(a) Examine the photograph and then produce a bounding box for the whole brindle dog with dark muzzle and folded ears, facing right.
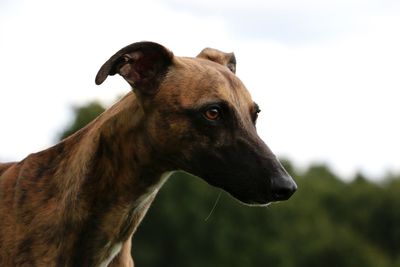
[0,42,296,266]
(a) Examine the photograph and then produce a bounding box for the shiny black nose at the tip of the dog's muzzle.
[271,174,297,201]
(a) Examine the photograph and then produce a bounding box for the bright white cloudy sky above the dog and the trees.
[0,0,400,179]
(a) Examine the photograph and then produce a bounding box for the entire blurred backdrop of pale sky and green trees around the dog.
[0,0,400,267]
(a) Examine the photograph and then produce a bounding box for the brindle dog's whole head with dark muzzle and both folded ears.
[96,42,297,205]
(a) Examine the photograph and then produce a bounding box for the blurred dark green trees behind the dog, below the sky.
[59,103,400,267]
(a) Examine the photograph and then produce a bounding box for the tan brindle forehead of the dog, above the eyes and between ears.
[160,57,253,108]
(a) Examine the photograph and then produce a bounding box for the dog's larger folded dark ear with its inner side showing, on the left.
[96,42,174,94]
